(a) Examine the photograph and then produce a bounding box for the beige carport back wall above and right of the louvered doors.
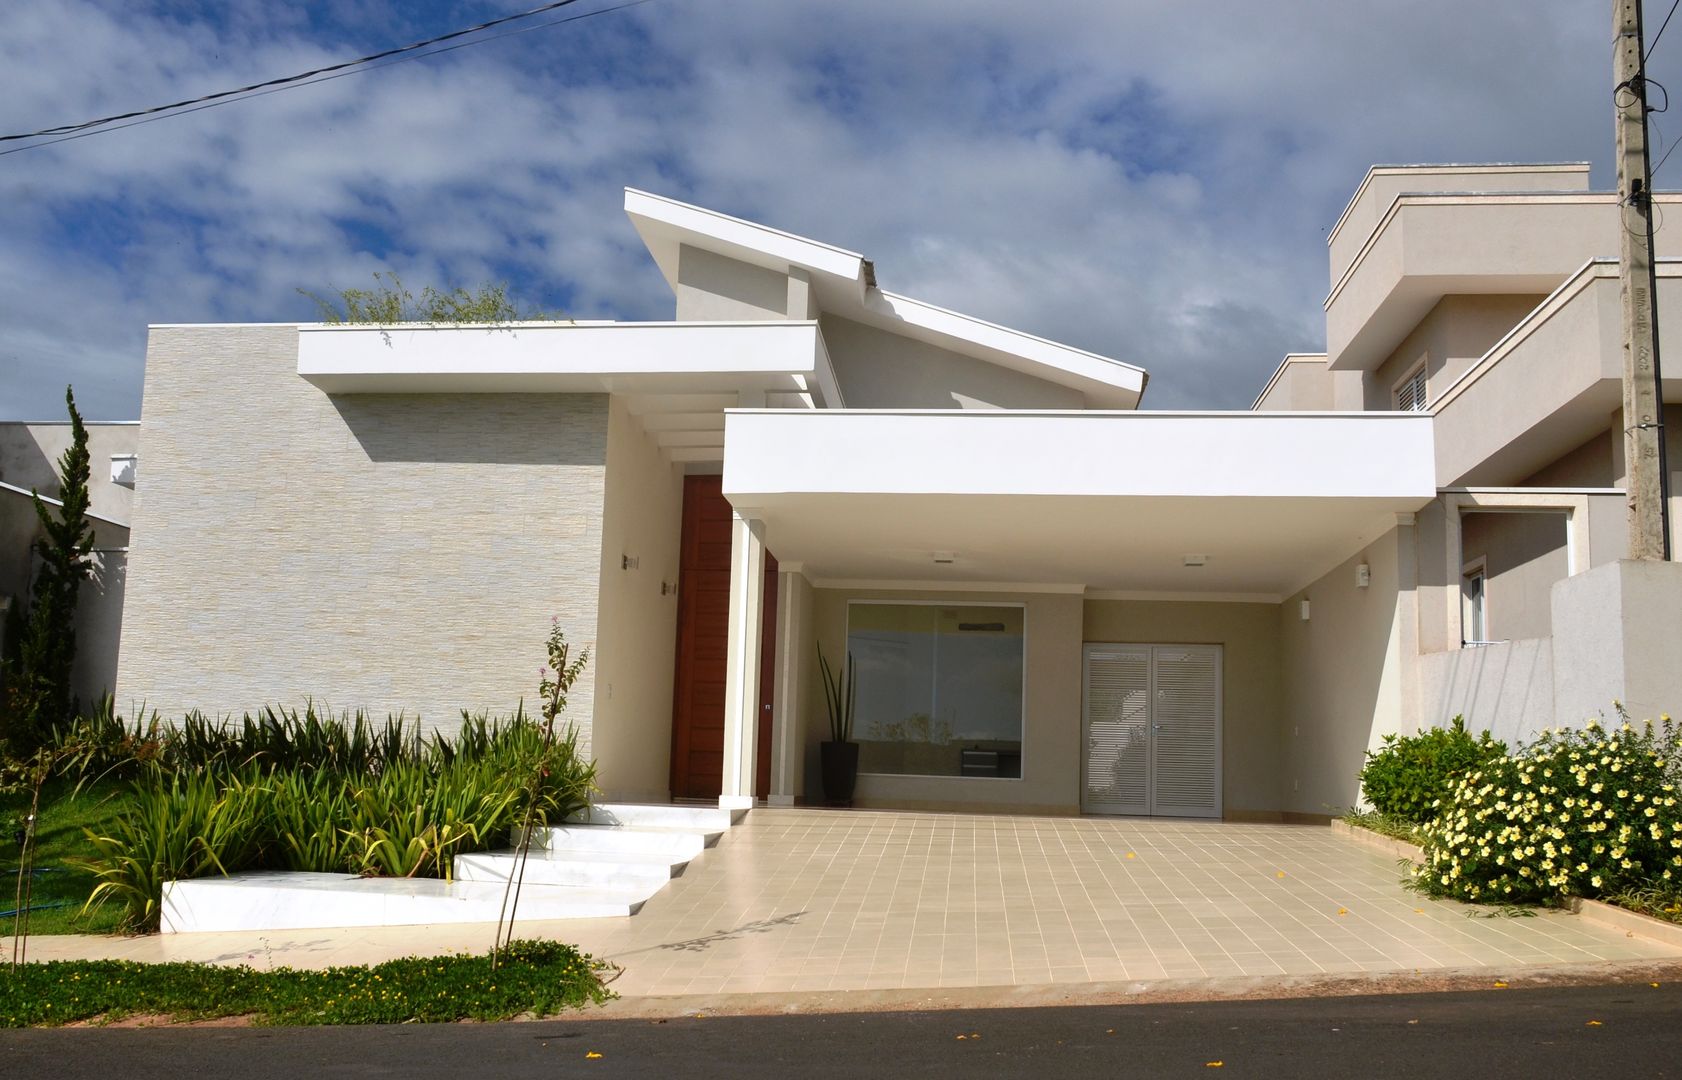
[1085,601,1283,818]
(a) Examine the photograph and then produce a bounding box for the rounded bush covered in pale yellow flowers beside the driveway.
[1416,717,1682,903]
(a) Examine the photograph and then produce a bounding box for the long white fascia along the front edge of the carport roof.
[723,409,1436,510]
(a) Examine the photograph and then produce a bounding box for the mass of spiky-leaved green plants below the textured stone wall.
[87,708,595,930]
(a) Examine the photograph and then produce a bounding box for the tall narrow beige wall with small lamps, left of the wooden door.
[594,395,683,801]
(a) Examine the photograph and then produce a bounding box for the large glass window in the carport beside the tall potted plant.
[848,602,1026,779]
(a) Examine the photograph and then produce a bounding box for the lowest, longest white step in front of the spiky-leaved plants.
[161,871,659,934]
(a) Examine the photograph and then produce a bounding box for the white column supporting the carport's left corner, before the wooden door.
[718,510,765,809]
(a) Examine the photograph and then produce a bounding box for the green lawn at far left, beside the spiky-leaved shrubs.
[0,781,126,937]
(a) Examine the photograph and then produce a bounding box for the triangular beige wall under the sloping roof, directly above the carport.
[819,315,1087,409]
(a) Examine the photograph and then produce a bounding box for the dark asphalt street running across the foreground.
[0,982,1682,1080]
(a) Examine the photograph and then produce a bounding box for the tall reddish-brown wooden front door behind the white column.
[671,476,777,799]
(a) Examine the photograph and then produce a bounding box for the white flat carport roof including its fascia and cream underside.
[723,410,1436,599]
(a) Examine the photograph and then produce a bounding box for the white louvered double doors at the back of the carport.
[1080,644,1221,818]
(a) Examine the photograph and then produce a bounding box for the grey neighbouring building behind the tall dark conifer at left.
[0,421,140,705]
